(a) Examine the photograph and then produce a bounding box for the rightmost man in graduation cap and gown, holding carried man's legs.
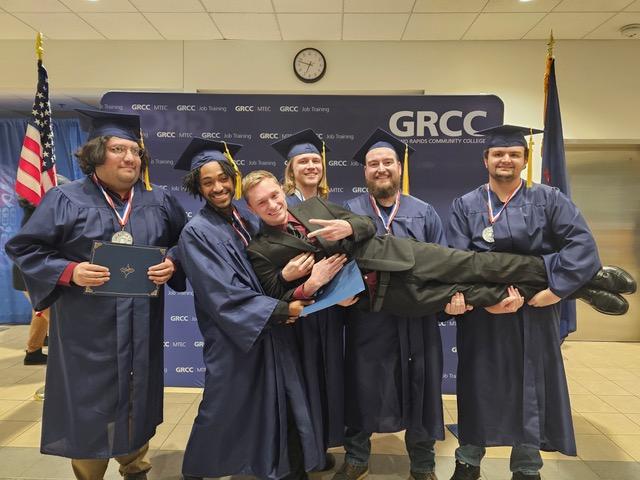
[447,125,635,480]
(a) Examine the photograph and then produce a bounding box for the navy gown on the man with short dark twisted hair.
[179,206,324,479]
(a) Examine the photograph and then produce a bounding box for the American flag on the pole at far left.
[16,60,57,205]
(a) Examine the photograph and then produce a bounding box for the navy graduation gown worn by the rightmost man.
[447,184,600,455]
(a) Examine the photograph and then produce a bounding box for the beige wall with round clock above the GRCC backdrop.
[0,40,640,142]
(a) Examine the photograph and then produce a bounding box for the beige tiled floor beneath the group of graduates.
[0,326,640,480]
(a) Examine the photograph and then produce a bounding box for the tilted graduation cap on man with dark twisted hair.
[173,137,242,199]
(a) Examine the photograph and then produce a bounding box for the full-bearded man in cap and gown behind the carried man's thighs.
[333,129,450,480]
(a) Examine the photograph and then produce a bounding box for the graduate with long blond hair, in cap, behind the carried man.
[271,129,344,464]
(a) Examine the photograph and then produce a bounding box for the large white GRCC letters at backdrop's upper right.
[389,110,487,137]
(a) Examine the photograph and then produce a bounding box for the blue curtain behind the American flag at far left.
[0,119,86,324]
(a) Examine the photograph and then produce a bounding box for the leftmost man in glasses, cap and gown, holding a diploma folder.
[6,110,186,480]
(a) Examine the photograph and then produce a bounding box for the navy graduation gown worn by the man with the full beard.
[345,194,446,439]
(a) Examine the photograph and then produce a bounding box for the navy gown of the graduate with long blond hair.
[287,195,345,449]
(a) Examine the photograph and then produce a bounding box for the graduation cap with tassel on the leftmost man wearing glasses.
[76,108,151,190]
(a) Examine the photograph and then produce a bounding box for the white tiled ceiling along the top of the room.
[0,0,640,41]
